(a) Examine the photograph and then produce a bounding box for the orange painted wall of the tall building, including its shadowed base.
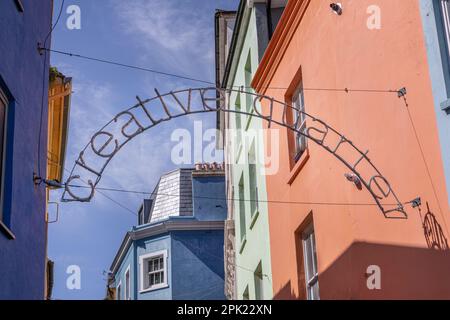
[253,0,450,299]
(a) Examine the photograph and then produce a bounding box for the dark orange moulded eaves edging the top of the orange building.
[251,0,311,95]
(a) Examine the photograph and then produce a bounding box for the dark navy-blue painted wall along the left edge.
[0,0,52,299]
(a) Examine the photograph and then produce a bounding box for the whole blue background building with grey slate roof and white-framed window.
[110,165,227,300]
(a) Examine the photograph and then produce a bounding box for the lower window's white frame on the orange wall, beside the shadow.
[302,223,320,300]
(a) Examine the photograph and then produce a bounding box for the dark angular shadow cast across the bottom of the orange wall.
[319,242,450,299]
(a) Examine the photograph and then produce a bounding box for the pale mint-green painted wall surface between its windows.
[226,4,273,299]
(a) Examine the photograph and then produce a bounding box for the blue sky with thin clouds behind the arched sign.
[48,0,238,299]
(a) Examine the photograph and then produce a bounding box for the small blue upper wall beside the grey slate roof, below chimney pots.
[192,176,227,221]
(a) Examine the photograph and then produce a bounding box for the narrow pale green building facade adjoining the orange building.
[216,1,285,299]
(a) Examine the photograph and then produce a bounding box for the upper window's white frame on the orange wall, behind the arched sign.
[291,83,308,161]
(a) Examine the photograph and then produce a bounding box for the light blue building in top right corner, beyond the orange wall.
[420,0,450,203]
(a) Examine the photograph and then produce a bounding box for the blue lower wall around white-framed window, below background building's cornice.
[114,230,225,300]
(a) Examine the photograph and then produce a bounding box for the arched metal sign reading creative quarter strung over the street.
[61,87,407,218]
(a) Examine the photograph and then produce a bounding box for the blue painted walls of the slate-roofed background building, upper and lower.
[114,175,227,300]
